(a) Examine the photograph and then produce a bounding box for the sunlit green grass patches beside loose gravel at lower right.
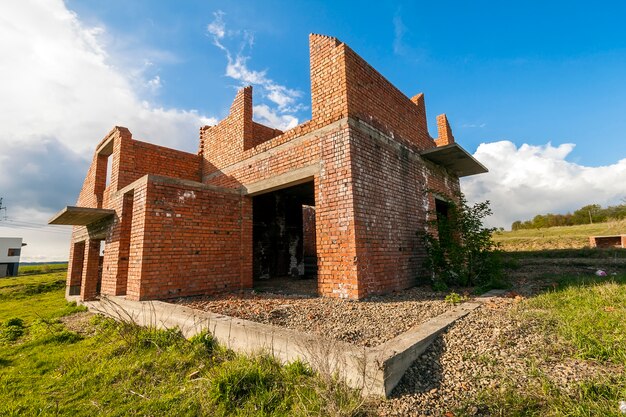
[461,274,626,417]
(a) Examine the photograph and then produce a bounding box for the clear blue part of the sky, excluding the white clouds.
[67,0,626,166]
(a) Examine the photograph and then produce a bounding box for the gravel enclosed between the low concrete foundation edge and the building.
[177,287,452,347]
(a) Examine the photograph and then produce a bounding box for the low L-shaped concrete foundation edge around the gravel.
[78,290,504,396]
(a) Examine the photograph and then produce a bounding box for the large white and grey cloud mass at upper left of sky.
[0,0,216,260]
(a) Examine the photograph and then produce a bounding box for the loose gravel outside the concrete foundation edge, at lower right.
[374,268,626,416]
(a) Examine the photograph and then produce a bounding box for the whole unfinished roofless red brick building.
[50,35,486,300]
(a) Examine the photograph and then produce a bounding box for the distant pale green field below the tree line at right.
[493,220,626,252]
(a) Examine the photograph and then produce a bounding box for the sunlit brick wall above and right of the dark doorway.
[206,121,357,298]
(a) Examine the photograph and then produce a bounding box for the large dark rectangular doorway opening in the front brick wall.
[252,180,317,295]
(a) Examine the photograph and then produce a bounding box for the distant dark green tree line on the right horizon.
[511,202,626,230]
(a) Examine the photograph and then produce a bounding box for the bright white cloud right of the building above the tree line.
[462,141,626,228]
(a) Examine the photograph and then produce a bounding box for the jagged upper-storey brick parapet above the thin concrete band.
[200,34,435,182]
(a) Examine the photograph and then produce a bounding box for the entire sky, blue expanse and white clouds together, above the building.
[0,0,626,261]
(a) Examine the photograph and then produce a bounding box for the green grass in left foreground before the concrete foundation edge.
[0,273,361,416]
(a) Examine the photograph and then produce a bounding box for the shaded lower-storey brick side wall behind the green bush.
[351,123,459,297]
